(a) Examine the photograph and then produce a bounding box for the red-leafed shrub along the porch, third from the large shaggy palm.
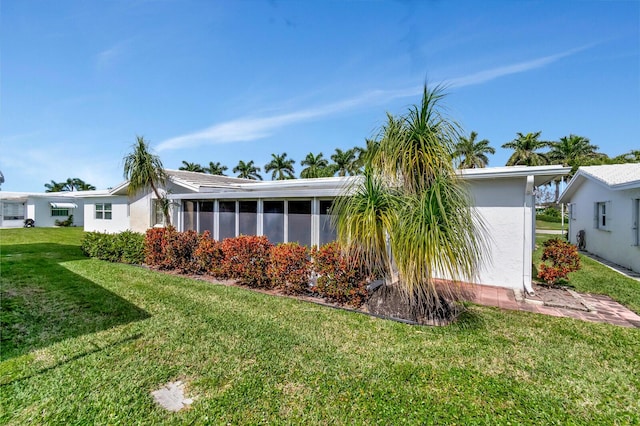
[221,235,273,287]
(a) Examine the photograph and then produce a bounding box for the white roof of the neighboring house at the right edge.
[559,163,640,203]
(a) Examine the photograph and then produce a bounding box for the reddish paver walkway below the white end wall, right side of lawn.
[473,285,640,328]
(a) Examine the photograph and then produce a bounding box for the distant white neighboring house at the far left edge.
[0,191,101,228]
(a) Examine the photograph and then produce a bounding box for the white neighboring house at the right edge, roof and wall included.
[560,163,640,272]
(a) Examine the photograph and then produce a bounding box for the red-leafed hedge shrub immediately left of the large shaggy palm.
[312,243,369,307]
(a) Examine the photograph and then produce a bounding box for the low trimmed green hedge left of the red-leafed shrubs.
[80,231,145,264]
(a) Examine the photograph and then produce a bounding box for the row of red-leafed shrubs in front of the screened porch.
[144,228,369,307]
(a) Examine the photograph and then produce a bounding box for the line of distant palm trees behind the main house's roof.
[180,131,640,180]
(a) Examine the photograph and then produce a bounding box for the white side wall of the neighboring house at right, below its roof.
[569,179,640,272]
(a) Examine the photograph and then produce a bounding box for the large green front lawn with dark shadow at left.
[0,228,640,424]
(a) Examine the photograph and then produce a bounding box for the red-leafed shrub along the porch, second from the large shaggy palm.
[268,243,311,294]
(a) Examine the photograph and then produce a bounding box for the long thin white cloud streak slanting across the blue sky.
[157,45,592,151]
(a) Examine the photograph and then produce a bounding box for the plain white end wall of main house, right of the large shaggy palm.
[470,178,532,289]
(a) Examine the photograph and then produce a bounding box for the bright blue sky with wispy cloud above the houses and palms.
[0,0,640,191]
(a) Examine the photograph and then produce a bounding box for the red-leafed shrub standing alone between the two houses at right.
[538,238,580,285]
